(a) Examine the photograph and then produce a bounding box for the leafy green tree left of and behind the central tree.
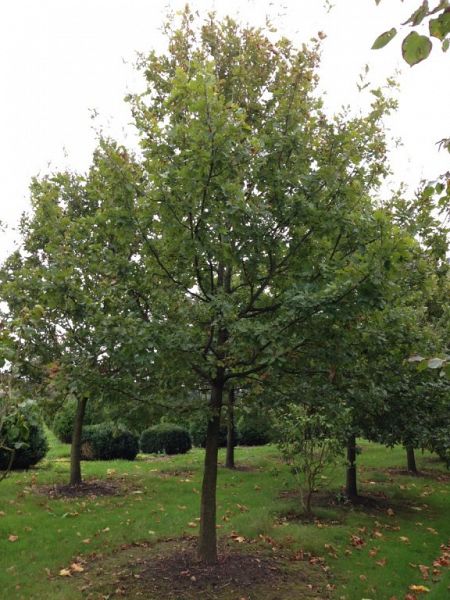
[0,141,160,485]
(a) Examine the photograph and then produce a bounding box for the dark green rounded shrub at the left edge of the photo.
[0,403,48,470]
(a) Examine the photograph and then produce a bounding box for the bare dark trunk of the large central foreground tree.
[198,381,224,564]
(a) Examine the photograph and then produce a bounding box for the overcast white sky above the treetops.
[0,0,450,258]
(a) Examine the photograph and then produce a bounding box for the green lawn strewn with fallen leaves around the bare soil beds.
[0,438,450,600]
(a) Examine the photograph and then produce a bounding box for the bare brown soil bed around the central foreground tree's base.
[68,537,332,600]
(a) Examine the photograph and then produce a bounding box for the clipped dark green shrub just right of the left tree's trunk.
[81,423,139,460]
